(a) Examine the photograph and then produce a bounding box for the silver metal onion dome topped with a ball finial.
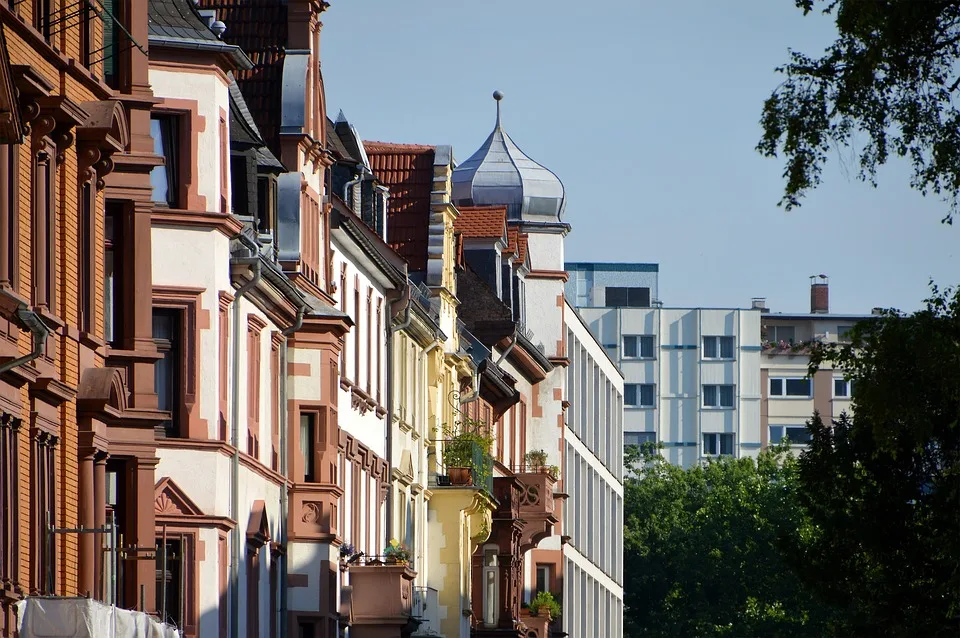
[453,91,565,222]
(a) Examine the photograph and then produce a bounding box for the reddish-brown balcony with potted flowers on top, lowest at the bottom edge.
[349,556,417,638]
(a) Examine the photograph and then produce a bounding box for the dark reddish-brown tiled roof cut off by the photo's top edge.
[194,0,287,157]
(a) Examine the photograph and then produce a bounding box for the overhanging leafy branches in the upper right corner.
[757,0,960,223]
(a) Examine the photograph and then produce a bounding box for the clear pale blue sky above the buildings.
[320,0,960,312]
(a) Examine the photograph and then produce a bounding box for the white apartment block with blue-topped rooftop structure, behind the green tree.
[567,263,763,466]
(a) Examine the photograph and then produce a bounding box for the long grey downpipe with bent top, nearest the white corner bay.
[230,233,263,638]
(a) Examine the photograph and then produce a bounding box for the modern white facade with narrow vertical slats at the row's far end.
[562,303,624,636]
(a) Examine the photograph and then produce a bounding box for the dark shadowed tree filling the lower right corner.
[794,287,960,637]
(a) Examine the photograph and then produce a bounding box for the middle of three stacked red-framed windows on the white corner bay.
[153,308,183,437]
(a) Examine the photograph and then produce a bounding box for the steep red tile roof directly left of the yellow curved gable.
[363,142,436,272]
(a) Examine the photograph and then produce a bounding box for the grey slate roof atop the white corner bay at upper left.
[147,0,253,69]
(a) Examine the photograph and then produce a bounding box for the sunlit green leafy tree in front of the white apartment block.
[624,448,828,638]
